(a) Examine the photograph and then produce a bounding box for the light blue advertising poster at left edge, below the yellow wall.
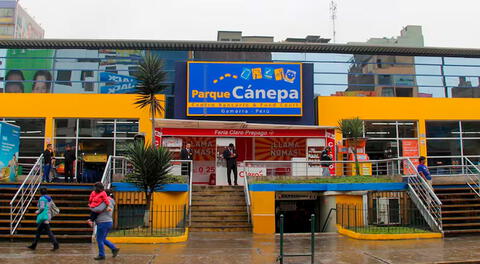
[0,122,20,182]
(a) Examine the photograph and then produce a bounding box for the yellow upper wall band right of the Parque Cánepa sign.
[317,96,480,155]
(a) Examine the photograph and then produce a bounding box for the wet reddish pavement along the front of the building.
[0,233,480,264]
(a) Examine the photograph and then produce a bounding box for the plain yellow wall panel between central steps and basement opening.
[250,192,275,234]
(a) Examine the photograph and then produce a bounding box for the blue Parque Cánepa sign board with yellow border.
[187,62,302,116]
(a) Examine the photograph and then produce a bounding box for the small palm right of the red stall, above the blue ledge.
[337,117,363,175]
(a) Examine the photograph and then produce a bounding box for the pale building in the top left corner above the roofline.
[0,0,45,39]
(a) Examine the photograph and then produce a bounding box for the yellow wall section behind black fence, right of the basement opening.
[335,195,363,226]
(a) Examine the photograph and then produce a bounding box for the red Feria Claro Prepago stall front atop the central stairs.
[156,120,335,185]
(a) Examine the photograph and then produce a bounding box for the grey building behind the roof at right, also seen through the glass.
[344,26,424,97]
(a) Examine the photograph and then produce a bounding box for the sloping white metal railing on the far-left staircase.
[10,154,43,235]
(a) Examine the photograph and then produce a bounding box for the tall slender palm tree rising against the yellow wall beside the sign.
[134,52,168,142]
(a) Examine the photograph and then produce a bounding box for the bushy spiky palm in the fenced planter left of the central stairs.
[126,141,172,226]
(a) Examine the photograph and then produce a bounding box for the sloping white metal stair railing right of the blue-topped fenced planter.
[405,159,443,232]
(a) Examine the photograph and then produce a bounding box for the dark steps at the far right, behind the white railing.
[433,185,480,236]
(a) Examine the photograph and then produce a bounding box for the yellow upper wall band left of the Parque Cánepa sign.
[0,93,165,143]
